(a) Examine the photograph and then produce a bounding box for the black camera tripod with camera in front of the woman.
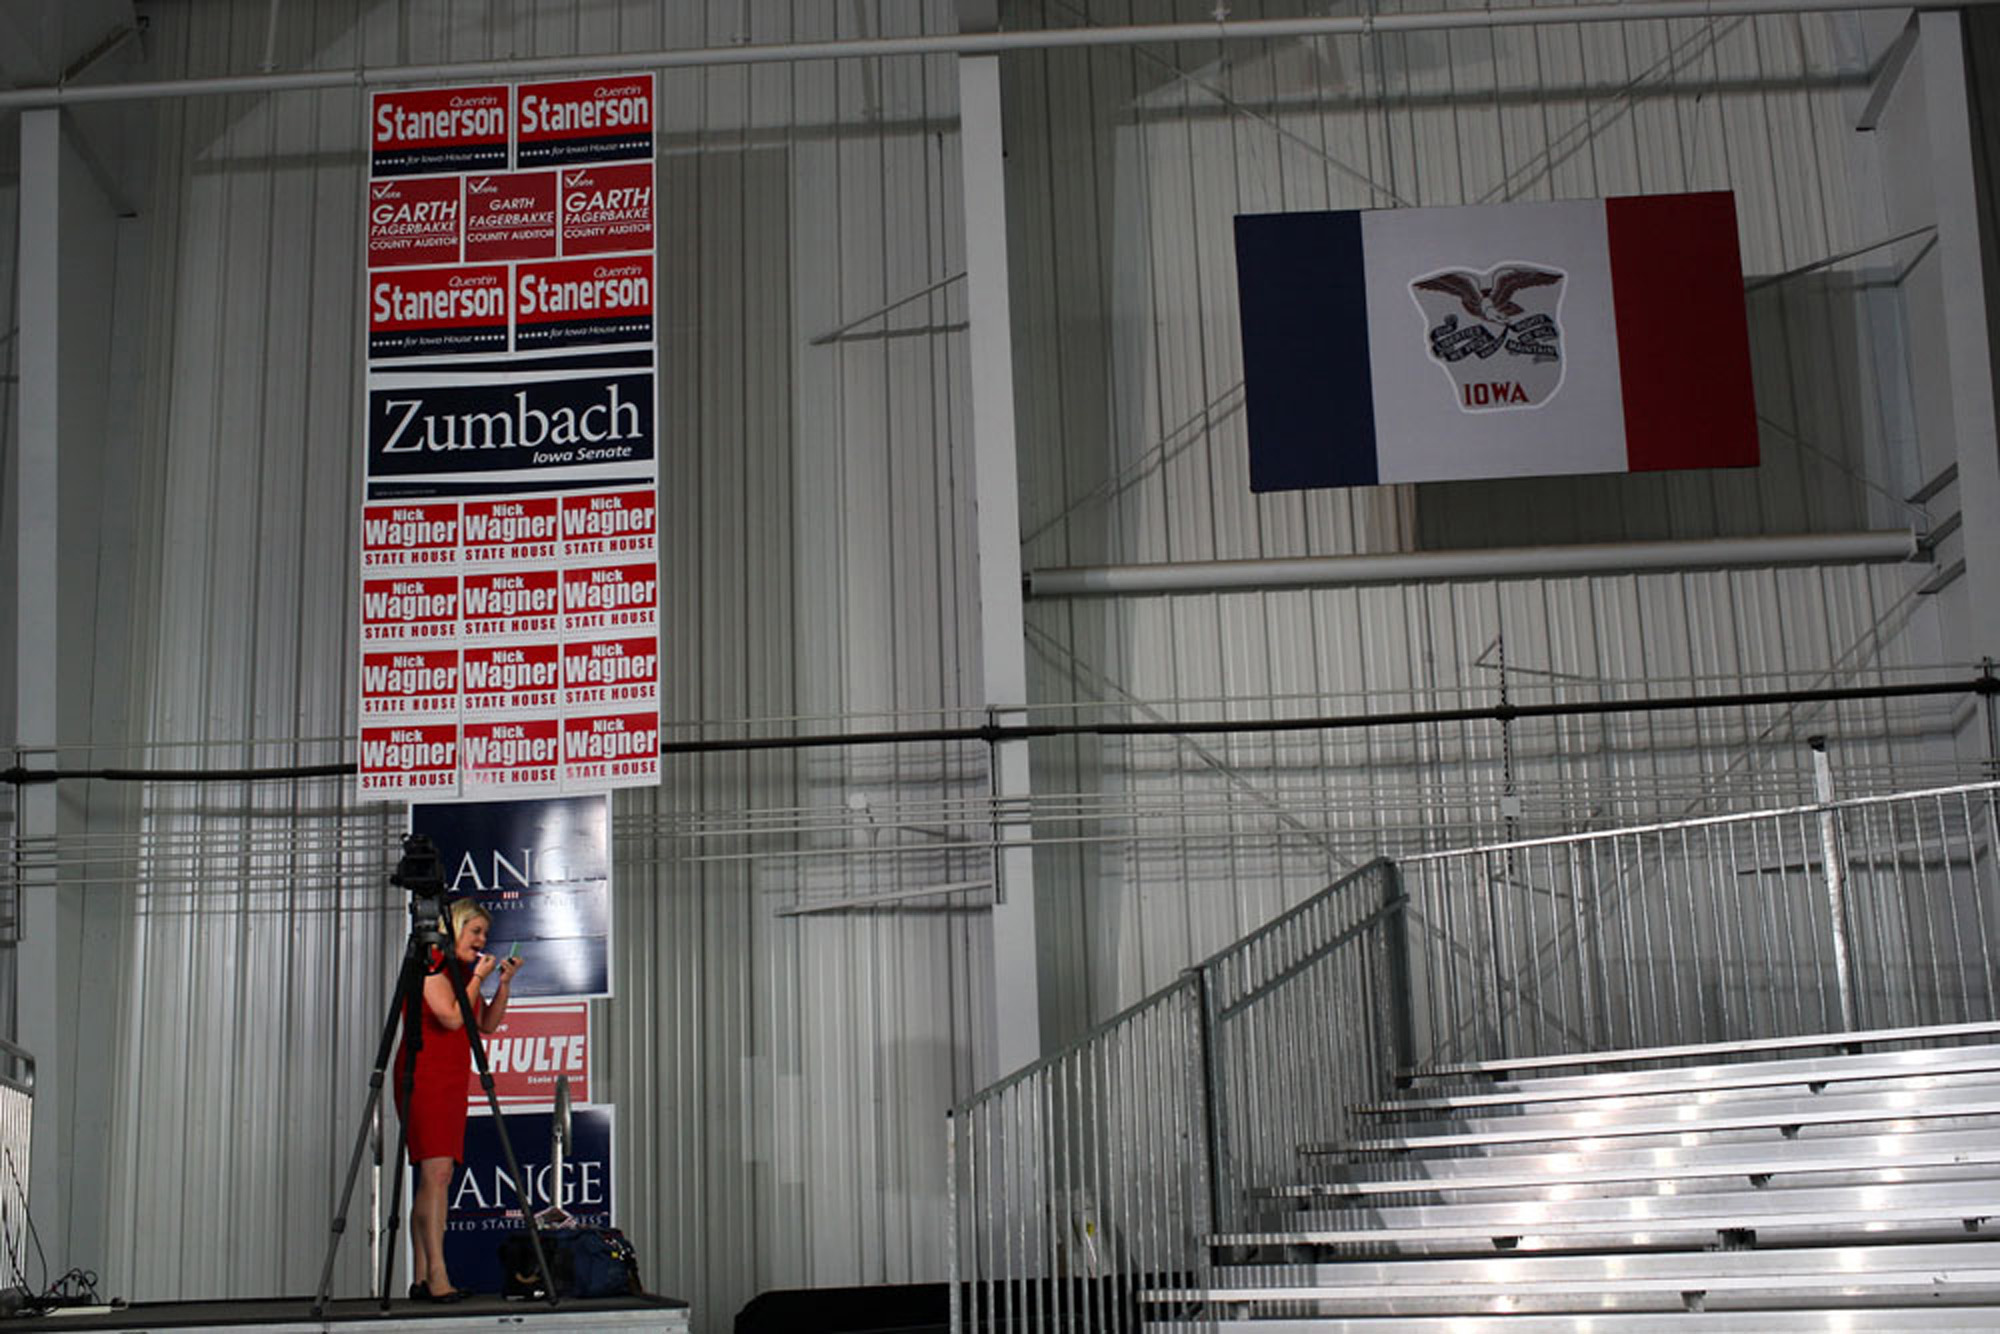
[312,834,562,1318]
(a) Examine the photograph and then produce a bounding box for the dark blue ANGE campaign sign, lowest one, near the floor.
[444,1106,612,1292]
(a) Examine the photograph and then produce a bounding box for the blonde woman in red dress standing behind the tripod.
[390,898,520,1302]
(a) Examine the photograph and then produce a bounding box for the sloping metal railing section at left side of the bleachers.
[946,860,1410,1334]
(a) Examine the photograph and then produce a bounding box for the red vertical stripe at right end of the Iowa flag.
[1604,190,1758,472]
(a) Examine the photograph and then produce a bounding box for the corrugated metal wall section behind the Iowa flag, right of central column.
[1006,0,1972,1032]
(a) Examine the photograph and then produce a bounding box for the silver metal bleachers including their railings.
[946,784,2000,1334]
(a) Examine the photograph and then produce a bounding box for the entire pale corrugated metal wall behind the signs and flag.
[0,0,1992,1330]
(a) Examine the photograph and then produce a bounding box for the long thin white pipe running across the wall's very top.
[0,0,2000,110]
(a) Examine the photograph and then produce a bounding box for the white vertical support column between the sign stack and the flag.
[958,56,1042,1072]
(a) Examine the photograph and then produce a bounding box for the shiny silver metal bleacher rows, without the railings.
[1140,1022,2000,1334]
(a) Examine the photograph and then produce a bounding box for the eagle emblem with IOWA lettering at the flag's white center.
[1410,262,1568,412]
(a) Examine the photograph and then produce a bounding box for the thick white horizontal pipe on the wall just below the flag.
[1026,528,1924,598]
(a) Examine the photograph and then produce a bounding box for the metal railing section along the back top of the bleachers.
[1402,784,2000,1064]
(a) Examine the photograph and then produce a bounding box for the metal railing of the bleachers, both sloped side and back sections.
[946,782,2000,1334]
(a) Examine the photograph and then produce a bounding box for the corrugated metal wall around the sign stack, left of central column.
[68,0,992,1328]
